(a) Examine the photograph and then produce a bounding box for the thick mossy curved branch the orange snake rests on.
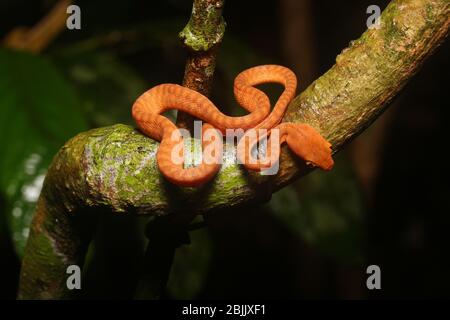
[19,0,450,298]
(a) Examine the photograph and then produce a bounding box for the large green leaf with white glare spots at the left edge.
[0,49,88,255]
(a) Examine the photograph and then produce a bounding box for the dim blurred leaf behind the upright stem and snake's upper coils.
[51,22,270,122]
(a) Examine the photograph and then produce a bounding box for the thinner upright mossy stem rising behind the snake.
[177,0,225,129]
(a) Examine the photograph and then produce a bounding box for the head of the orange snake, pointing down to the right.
[286,124,334,171]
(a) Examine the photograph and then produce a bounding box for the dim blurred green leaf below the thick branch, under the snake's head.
[267,153,365,261]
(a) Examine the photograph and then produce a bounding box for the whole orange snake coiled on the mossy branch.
[132,65,334,187]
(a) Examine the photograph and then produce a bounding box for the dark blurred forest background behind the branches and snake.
[0,0,450,299]
